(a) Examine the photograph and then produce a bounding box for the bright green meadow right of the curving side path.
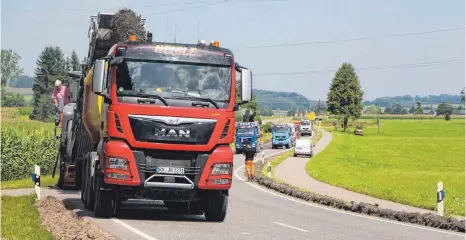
[306,119,465,216]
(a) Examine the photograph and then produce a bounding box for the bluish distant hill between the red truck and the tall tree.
[253,89,316,111]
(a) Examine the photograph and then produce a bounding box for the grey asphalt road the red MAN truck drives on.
[63,144,465,240]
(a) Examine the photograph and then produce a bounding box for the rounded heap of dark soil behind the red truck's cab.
[110,8,146,42]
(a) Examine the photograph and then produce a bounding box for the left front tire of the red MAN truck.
[93,172,121,218]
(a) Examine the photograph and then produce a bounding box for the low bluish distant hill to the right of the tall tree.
[364,94,461,107]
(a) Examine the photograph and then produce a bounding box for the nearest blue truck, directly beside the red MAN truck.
[235,122,261,154]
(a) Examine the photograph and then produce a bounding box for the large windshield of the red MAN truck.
[116,59,231,102]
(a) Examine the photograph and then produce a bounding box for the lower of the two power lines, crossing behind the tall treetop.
[254,60,464,77]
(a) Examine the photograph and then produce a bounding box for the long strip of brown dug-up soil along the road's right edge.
[254,159,465,232]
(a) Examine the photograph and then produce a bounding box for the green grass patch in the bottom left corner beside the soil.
[1,194,53,240]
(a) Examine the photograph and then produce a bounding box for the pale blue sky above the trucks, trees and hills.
[1,0,465,99]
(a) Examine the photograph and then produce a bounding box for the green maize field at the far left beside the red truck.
[1,107,58,181]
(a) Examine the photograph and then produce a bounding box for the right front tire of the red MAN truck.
[204,193,228,222]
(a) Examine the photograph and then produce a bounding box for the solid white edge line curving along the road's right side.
[235,152,465,237]
